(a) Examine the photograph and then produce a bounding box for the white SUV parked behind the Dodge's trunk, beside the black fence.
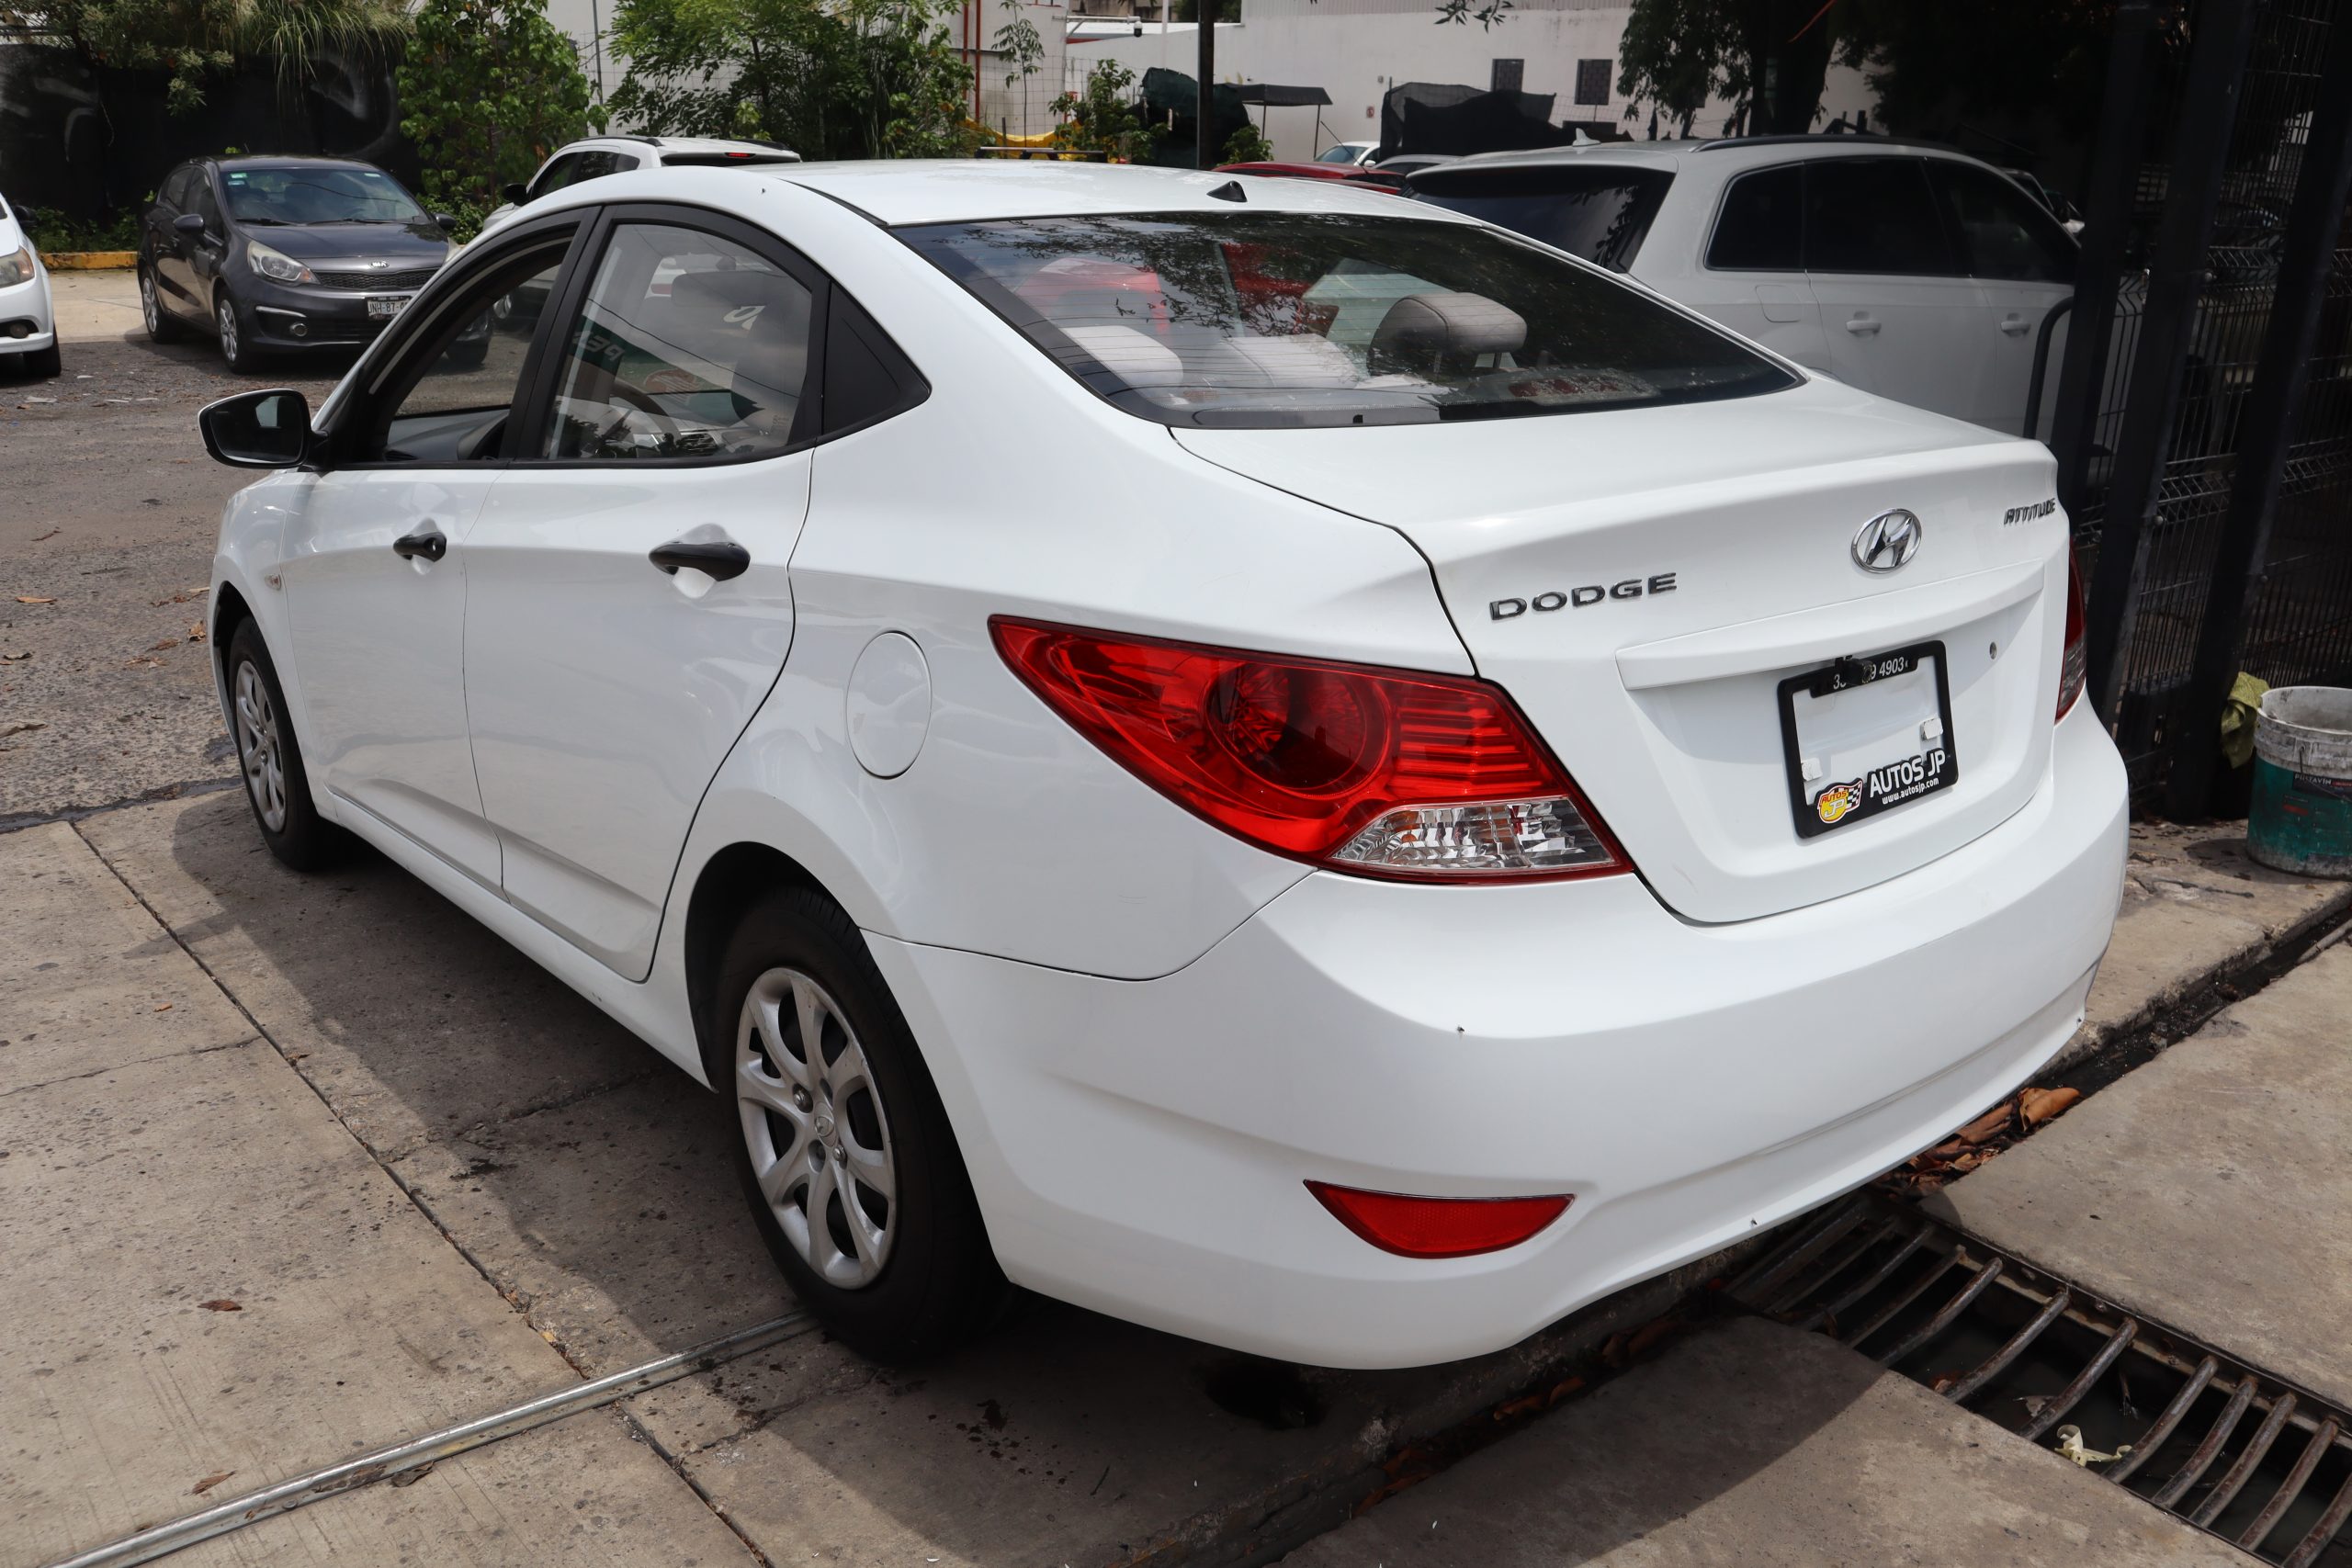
[1411,136,2075,434]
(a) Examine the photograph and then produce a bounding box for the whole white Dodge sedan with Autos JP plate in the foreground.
[202,163,2124,1366]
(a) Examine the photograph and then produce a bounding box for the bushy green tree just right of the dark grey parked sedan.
[398,0,591,232]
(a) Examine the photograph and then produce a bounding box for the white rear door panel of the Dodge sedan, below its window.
[468,451,809,980]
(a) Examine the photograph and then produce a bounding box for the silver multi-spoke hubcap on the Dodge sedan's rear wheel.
[736,968,899,1291]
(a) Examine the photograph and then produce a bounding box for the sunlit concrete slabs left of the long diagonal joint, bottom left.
[0,825,748,1568]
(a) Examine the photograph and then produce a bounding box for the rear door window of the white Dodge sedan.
[543,223,814,461]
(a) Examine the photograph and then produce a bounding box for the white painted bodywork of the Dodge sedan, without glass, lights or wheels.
[214,163,2124,1366]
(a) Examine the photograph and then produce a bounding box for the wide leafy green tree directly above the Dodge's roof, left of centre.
[609,0,974,157]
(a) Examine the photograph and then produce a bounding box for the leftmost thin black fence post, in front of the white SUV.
[2025,0,2157,514]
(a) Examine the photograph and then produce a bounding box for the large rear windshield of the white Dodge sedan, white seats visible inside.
[896,211,1794,428]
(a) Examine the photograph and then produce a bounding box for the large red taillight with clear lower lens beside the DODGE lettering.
[988,616,1625,879]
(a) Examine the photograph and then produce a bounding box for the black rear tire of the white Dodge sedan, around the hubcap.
[706,888,1012,1363]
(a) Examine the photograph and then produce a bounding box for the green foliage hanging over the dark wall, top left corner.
[0,0,409,115]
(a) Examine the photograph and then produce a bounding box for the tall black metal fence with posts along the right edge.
[2051,0,2352,816]
